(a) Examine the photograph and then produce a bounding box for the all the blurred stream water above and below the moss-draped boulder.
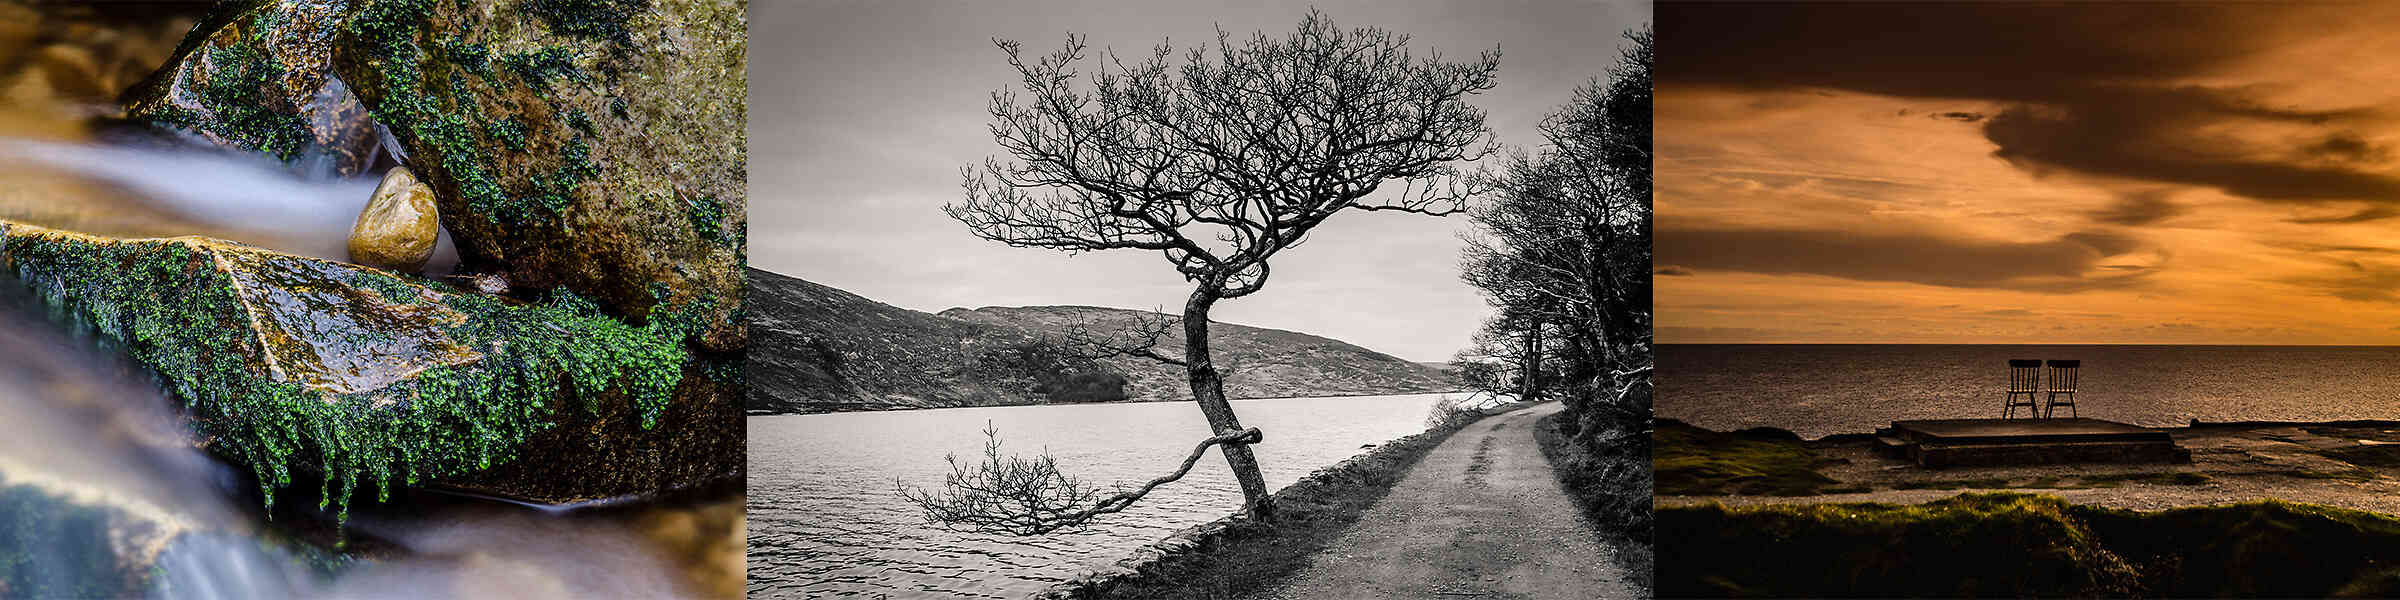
[0,7,744,600]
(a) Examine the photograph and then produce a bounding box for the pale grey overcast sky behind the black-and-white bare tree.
[749,0,1649,360]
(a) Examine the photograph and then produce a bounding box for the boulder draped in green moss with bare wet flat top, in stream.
[0,223,744,514]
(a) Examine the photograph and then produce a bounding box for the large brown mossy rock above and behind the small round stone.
[334,0,746,350]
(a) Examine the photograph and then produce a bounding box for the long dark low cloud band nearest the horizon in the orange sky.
[1654,228,2155,293]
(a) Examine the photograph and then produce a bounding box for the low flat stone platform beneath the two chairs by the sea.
[1874,418,2191,468]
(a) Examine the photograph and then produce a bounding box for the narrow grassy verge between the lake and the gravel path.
[1066,403,1524,600]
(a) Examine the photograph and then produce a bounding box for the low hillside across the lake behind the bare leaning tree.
[749,269,1457,415]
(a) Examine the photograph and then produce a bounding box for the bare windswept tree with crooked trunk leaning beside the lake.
[912,10,1500,533]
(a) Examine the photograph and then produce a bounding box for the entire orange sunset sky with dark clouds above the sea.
[1656,2,2400,343]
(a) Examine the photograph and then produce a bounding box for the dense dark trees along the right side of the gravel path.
[1462,31,1651,439]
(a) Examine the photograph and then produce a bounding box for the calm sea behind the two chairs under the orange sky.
[1656,343,2400,437]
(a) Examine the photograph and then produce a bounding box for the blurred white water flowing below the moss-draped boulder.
[0,289,710,600]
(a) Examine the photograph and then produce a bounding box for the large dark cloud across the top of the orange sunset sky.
[1656,2,2400,204]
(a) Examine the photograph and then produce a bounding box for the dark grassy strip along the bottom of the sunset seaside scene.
[1658,492,2400,598]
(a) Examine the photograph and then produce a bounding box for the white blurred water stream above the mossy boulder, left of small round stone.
[0,139,458,274]
